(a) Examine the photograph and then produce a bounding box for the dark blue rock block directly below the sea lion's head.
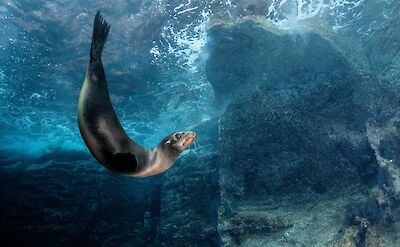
[159,151,220,247]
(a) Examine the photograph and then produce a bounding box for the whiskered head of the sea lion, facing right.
[160,131,196,158]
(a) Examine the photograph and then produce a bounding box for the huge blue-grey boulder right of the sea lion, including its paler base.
[206,20,384,246]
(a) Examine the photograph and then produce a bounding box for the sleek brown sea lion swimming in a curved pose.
[78,12,196,177]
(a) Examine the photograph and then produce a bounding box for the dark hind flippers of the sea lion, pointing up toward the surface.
[90,11,110,63]
